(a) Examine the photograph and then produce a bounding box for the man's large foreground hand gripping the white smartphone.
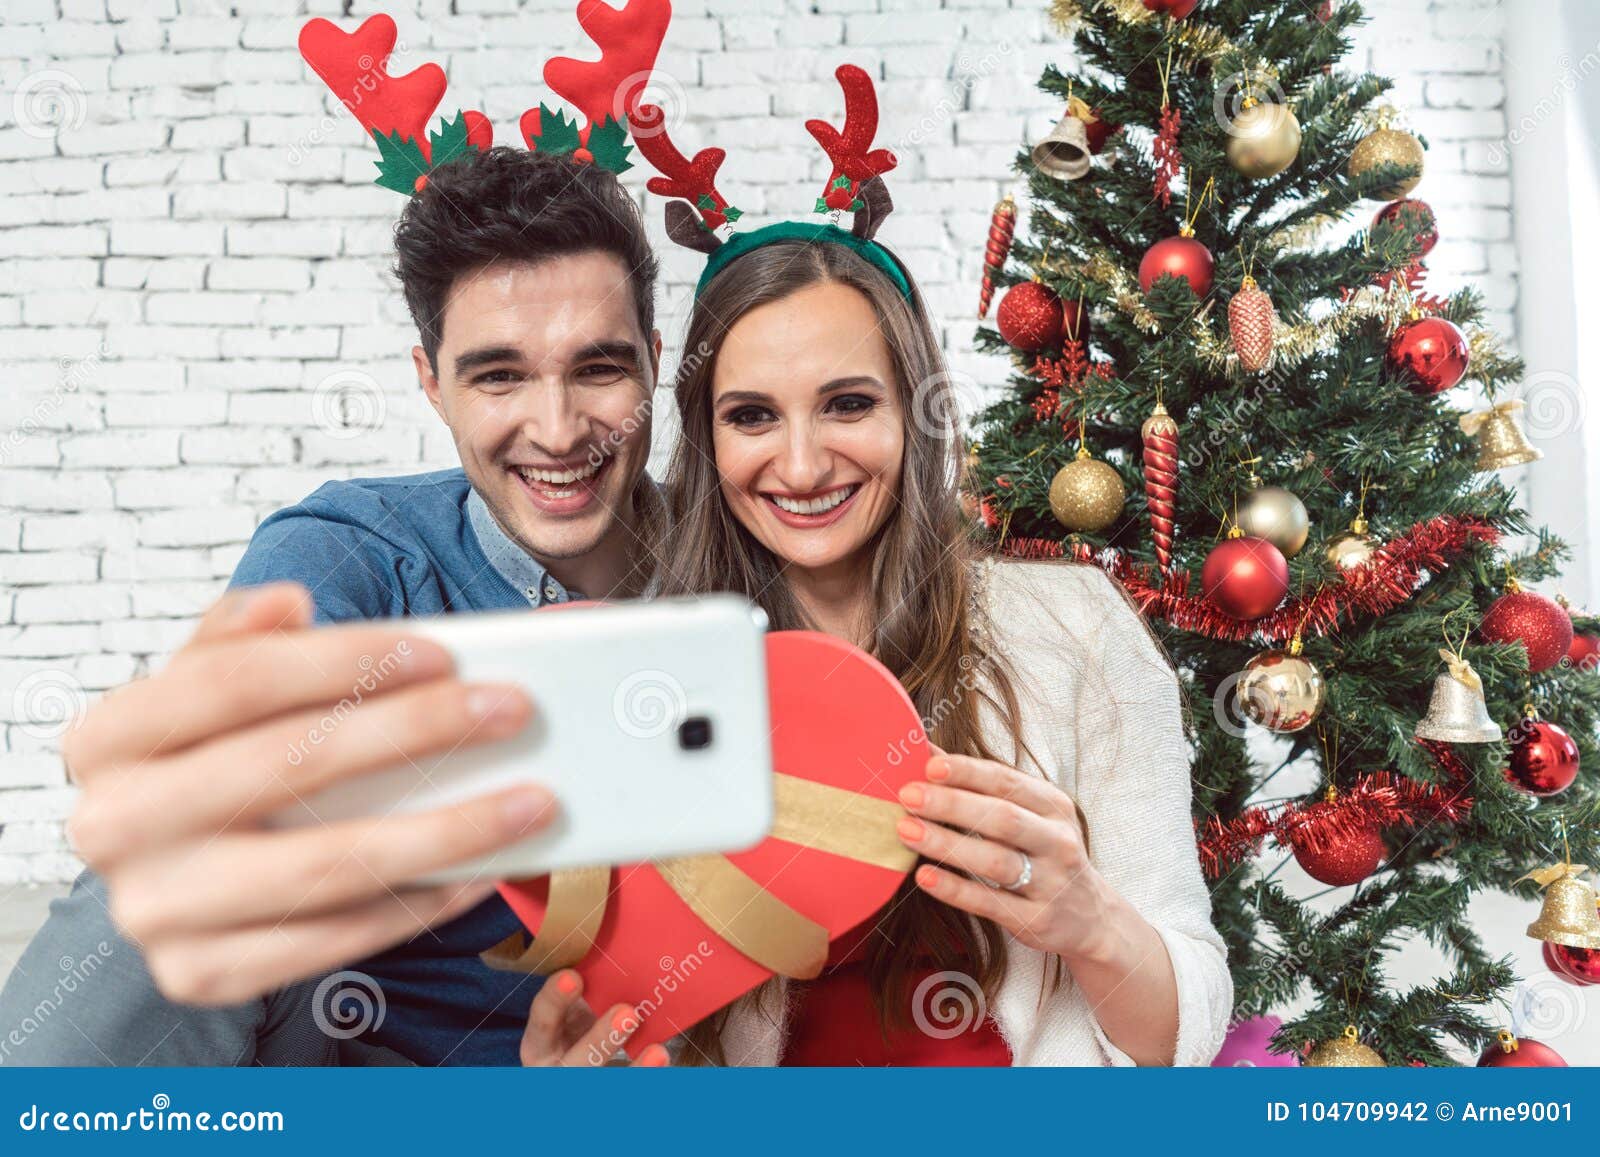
[62,583,555,1003]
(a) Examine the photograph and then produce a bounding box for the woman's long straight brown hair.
[658,242,1022,1064]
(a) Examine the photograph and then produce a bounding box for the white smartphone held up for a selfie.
[274,595,773,883]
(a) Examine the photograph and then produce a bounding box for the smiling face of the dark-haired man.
[411,251,661,562]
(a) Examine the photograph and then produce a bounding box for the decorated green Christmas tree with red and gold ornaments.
[968,0,1600,1064]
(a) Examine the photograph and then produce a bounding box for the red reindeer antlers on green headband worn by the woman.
[634,64,912,301]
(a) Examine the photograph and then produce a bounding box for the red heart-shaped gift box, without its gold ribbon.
[499,631,930,1056]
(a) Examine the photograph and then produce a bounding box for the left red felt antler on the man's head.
[299,13,494,160]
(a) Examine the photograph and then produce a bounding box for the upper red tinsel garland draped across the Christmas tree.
[1002,514,1501,643]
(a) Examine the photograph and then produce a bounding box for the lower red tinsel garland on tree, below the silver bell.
[1195,739,1472,879]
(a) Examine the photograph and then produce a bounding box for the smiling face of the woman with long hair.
[712,282,906,570]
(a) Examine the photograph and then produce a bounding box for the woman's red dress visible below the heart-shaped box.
[778,925,1011,1067]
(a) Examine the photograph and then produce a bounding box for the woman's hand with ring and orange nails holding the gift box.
[899,747,1138,962]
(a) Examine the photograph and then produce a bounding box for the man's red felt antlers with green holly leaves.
[299,0,672,195]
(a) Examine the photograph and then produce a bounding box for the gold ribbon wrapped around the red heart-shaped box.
[482,775,917,979]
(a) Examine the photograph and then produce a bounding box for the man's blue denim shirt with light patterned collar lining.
[230,469,571,1064]
